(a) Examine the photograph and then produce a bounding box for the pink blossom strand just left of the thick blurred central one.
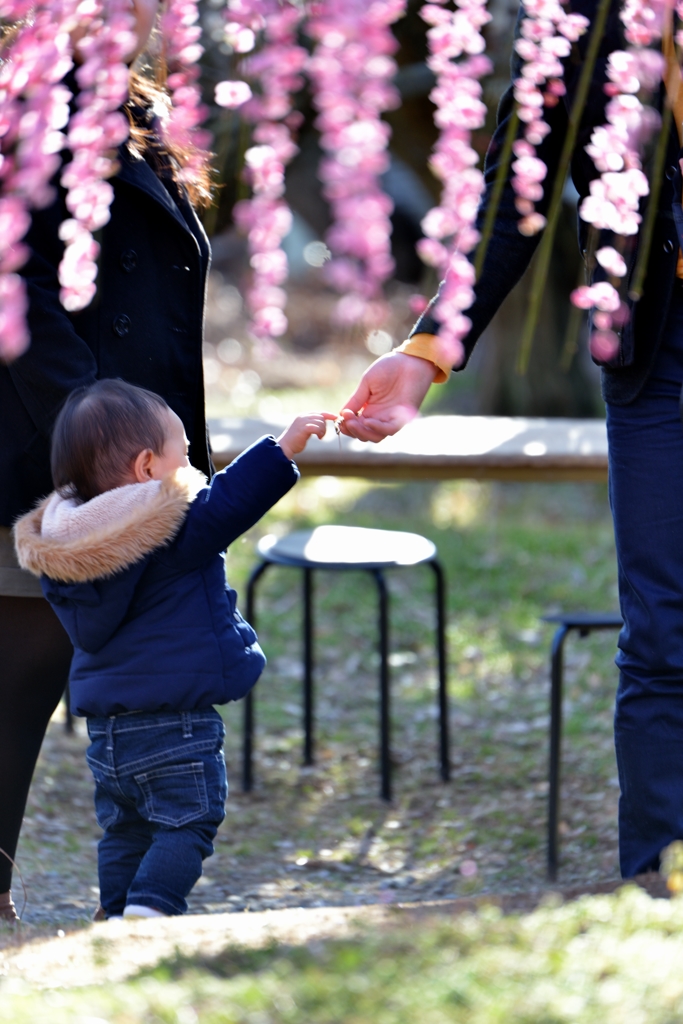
[216,0,308,350]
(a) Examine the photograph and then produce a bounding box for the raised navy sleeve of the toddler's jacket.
[162,437,299,570]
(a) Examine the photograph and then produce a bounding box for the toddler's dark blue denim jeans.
[86,708,227,918]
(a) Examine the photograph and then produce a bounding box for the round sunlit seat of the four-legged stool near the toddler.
[257,525,436,570]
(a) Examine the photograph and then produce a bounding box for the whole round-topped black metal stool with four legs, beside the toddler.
[242,526,450,800]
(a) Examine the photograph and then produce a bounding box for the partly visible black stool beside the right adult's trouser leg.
[542,611,624,882]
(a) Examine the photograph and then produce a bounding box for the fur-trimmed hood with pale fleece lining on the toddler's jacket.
[14,466,207,584]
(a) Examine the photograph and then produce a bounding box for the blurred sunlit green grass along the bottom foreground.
[0,889,683,1024]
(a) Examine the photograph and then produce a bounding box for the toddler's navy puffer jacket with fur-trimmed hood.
[14,437,298,716]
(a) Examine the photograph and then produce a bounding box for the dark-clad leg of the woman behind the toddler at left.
[0,596,73,893]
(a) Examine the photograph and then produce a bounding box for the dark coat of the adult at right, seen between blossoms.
[412,0,683,406]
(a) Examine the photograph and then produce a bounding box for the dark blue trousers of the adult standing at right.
[607,284,683,878]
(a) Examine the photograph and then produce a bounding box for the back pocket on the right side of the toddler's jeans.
[134,761,209,828]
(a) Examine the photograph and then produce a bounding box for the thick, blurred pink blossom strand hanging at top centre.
[306,0,405,326]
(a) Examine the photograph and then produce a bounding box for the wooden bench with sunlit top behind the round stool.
[209,416,607,482]
